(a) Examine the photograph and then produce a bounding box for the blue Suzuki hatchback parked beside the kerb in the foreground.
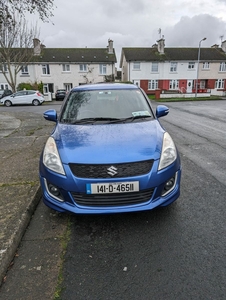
[40,83,181,214]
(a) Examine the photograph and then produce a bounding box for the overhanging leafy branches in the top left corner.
[0,0,54,22]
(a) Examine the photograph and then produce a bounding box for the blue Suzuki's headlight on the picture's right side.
[158,132,177,170]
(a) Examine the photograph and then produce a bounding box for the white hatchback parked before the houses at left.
[0,90,45,106]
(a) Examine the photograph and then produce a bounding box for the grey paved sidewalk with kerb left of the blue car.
[0,110,54,285]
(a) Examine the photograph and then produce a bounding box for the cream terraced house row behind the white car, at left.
[0,39,117,95]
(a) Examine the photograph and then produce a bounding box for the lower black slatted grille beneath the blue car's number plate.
[71,189,154,207]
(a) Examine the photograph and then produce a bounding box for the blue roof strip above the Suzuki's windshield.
[71,83,139,92]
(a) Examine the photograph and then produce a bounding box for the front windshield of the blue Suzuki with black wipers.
[60,89,153,124]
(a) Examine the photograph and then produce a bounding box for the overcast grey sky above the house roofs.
[30,0,226,66]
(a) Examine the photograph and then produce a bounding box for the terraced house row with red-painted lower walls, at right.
[120,38,226,95]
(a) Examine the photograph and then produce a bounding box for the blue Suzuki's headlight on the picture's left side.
[43,137,65,175]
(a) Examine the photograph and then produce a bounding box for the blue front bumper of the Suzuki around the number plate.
[40,159,181,214]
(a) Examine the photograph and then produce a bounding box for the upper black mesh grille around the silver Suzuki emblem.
[69,160,153,178]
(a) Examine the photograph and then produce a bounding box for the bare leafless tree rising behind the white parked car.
[0,13,39,92]
